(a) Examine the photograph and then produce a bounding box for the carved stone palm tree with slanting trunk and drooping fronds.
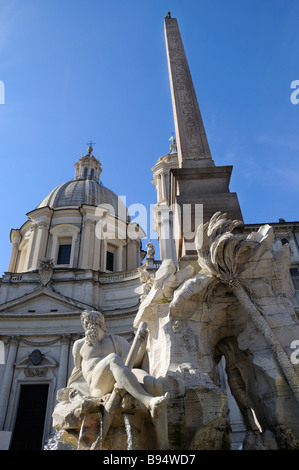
[196,212,299,402]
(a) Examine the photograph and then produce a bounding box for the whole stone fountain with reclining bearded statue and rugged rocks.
[53,213,299,450]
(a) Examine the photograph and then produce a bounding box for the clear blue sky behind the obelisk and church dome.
[0,0,299,275]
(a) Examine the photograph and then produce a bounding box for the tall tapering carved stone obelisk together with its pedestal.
[164,12,243,260]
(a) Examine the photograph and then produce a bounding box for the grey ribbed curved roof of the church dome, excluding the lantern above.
[37,179,129,220]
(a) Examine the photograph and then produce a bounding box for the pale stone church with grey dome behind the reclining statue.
[0,142,149,448]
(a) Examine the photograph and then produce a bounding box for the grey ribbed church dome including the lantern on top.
[37,147,129,221]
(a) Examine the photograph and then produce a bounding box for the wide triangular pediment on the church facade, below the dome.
[0,287,94,314]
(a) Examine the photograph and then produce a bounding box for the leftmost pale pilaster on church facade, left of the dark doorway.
[0,336,20,430]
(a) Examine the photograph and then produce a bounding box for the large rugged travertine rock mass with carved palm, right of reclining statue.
[135,213,299,449]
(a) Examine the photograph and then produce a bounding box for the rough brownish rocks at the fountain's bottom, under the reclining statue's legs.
[47,388,158,450]
